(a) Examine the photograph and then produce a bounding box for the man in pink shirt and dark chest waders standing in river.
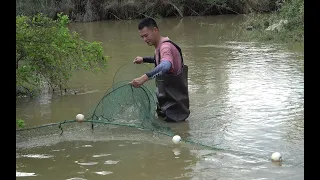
[131,18,190,122]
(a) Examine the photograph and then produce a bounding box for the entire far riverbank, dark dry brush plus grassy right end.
[16,0,304,45]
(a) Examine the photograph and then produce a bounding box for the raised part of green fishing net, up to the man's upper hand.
[86,64,169,131]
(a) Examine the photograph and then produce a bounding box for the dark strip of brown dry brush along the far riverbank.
[16,0,282,22]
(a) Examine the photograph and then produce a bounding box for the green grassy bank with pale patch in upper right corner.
[241,0,304,43]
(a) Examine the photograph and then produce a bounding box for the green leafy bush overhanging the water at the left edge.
[16,14,108,95]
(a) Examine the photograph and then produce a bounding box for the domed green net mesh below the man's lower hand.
[86,81,165,130]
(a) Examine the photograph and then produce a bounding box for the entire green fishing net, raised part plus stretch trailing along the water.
[16,65,221,148]
